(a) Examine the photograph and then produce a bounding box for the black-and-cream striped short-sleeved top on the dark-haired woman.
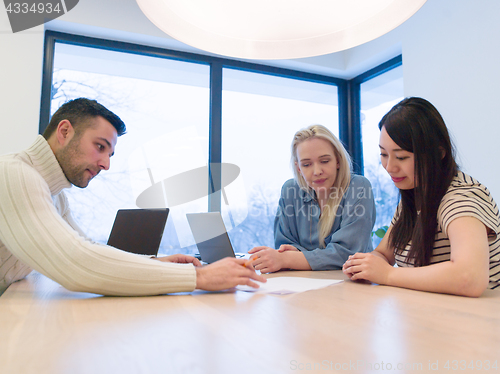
[392,172,500,289]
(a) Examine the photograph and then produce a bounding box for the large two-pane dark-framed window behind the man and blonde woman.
[40,32,342,254]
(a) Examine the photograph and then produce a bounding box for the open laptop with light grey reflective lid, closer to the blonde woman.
[186,212,250,264]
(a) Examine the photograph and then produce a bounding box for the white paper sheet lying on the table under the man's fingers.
[236,277,343,295]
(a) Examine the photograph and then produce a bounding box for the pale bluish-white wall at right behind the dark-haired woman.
[345,0,500,201]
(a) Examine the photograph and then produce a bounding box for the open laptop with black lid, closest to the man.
[107,208,169,256]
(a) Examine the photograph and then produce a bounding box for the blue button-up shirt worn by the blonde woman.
[274,175,376,270]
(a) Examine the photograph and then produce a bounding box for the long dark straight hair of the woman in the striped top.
[379,97,458,266]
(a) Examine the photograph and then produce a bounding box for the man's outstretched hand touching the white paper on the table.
[196,257,267,291]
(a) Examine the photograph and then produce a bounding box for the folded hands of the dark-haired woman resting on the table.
[342,252,394,284]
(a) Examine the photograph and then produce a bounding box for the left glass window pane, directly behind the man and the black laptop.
[51,43,210,253]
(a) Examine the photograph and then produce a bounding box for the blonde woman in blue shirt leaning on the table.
[249,125,375,273]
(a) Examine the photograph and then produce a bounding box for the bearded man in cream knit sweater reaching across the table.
[0,98,265,296]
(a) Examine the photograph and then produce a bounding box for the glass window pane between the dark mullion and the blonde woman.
[222,69,339,252]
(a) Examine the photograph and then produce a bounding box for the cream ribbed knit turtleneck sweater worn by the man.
[0,136,196,296]
